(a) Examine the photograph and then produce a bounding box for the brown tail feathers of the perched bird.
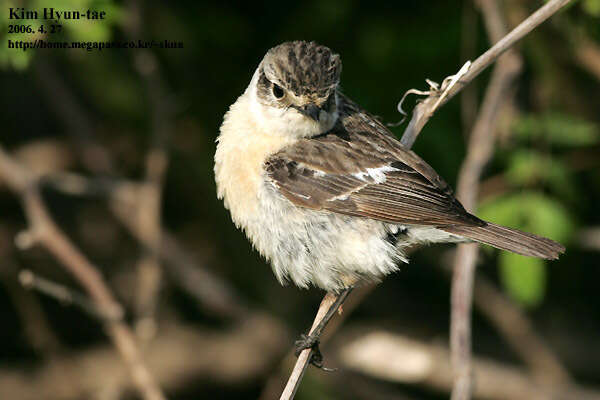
[439,222,565,260]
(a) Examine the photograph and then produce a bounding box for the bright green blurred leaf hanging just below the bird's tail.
[500,252,546,307]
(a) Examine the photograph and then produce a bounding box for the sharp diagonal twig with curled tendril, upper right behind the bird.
[401,0,573,148]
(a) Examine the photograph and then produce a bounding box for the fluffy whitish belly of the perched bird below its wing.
[245,182,405,291]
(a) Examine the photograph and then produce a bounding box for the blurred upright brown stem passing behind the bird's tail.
[450,0,522,400]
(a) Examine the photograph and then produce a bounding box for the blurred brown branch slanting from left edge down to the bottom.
[0,146,165,400]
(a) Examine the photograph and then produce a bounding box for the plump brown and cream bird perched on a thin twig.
[215,41,564,292]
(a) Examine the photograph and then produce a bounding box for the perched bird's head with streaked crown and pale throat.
[250,41,342,137]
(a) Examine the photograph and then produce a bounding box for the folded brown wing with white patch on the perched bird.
[265,92,485,226]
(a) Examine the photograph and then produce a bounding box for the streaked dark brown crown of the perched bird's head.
[263,41,342,98]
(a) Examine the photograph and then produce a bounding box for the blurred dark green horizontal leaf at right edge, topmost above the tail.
[514,113,600,146]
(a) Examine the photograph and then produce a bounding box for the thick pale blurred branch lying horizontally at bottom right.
[337,327,600,400]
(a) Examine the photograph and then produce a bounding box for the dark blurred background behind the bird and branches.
[0,0,600,399]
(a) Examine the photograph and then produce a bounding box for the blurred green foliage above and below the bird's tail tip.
[479,112,600,307]
